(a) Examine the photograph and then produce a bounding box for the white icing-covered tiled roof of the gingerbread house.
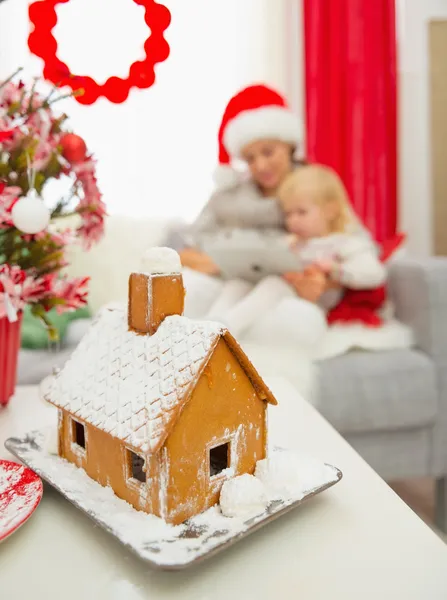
[46,308,276,452]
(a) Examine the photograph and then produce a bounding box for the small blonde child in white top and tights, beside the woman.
[208,165,386,336]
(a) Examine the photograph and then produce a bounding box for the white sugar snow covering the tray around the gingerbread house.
[7,432,339,567]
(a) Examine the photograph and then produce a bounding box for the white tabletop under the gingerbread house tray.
[0,379,447,600]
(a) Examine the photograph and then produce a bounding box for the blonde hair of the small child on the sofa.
[278,165,353,233]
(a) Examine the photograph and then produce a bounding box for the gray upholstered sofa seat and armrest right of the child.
[319,258,447,531]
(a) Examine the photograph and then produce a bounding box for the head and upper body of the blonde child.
[278,165,386,290]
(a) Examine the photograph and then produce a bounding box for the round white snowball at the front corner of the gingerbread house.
[220,475,268,518]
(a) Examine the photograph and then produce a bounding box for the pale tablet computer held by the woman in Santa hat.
[202,230,304,283]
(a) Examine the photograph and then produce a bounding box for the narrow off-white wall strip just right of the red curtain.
[397,0,447,256]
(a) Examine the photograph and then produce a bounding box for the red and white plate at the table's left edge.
[0,460,43,542]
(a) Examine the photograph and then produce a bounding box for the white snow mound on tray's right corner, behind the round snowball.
[255,450,327,500]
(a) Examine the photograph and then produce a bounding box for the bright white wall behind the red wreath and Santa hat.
[0,0,293,219]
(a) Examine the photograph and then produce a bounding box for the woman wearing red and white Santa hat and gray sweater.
[181,85,412,395]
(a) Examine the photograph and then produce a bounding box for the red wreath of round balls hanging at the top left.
[28,0,171,104]
